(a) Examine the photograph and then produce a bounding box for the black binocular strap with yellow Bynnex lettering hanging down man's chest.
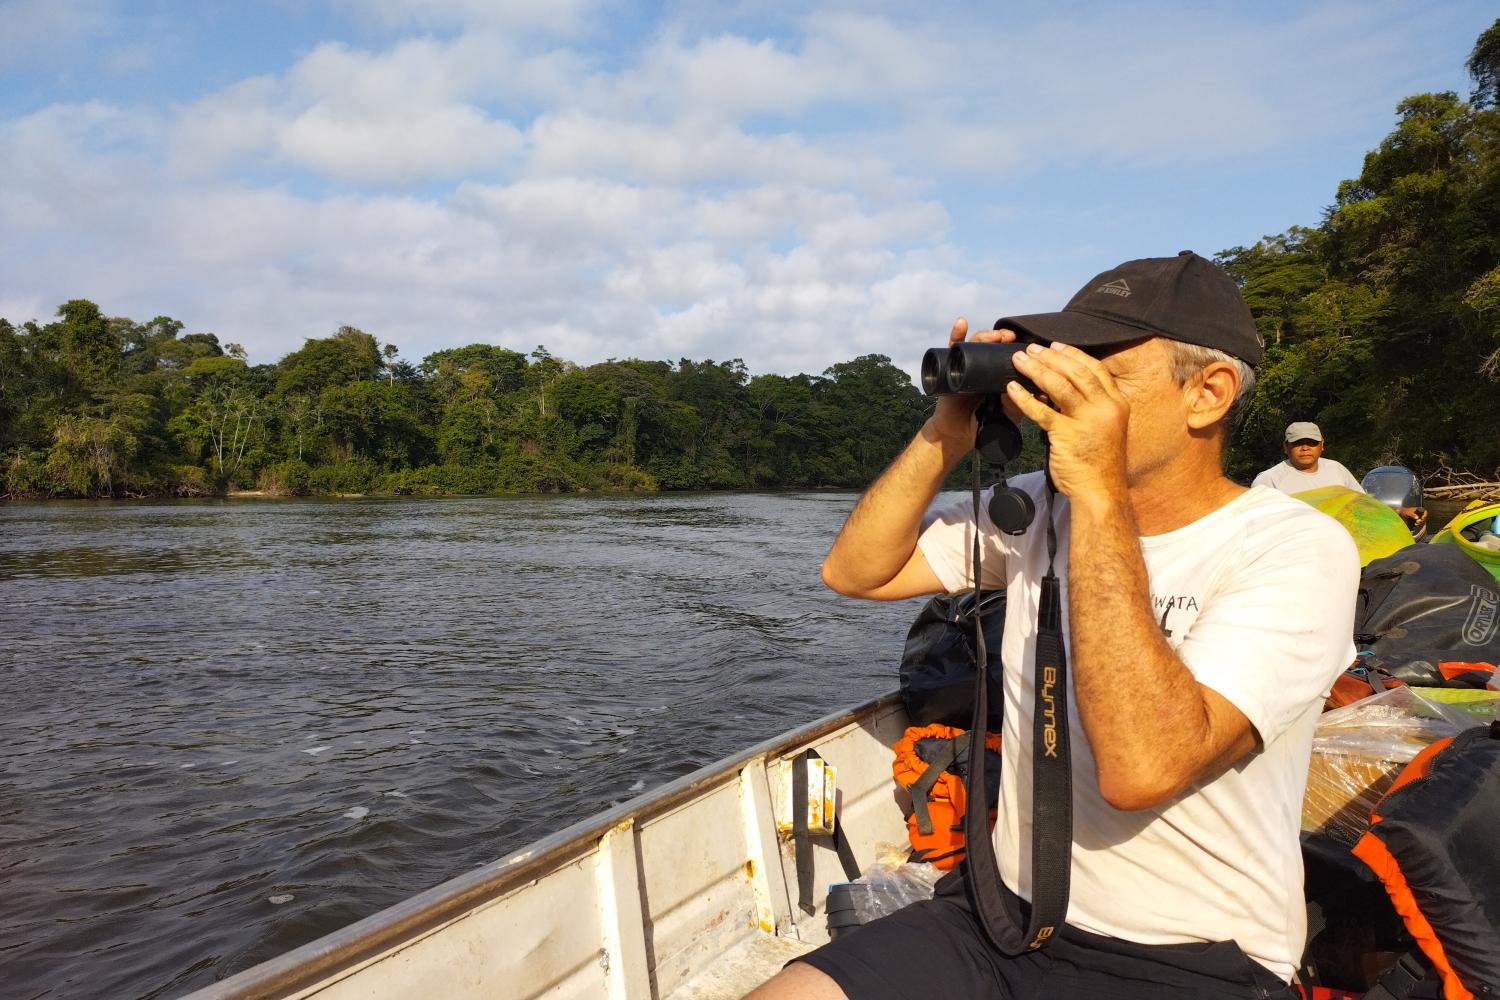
[963,446,1073,955]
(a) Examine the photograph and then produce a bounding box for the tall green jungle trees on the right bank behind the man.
[1218,21,1500,480]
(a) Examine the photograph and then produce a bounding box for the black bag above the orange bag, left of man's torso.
[902,591,1005,732]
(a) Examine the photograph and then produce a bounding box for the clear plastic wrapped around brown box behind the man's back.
[1302,687,1475,847]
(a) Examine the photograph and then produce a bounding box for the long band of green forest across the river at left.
[0,313,924,498]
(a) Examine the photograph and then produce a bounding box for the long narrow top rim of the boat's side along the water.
[183,691,900,1000]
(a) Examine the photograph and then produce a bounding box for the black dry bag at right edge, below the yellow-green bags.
[1355,544,1500,687]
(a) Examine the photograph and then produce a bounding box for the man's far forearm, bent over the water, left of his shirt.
[824,420,972,597]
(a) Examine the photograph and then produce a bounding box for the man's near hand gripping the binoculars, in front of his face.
[1007,342,1130,504]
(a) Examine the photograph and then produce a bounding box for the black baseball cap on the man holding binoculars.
[995,250,1266,367]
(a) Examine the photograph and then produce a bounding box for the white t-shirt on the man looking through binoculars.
[920,472,1359,979]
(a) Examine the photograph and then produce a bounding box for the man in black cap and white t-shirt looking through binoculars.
[753,252,1359,1000]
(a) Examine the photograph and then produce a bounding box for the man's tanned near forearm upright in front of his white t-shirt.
[1068,490,1253,808]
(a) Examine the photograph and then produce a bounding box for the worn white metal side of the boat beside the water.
[191,694,906,1000]
